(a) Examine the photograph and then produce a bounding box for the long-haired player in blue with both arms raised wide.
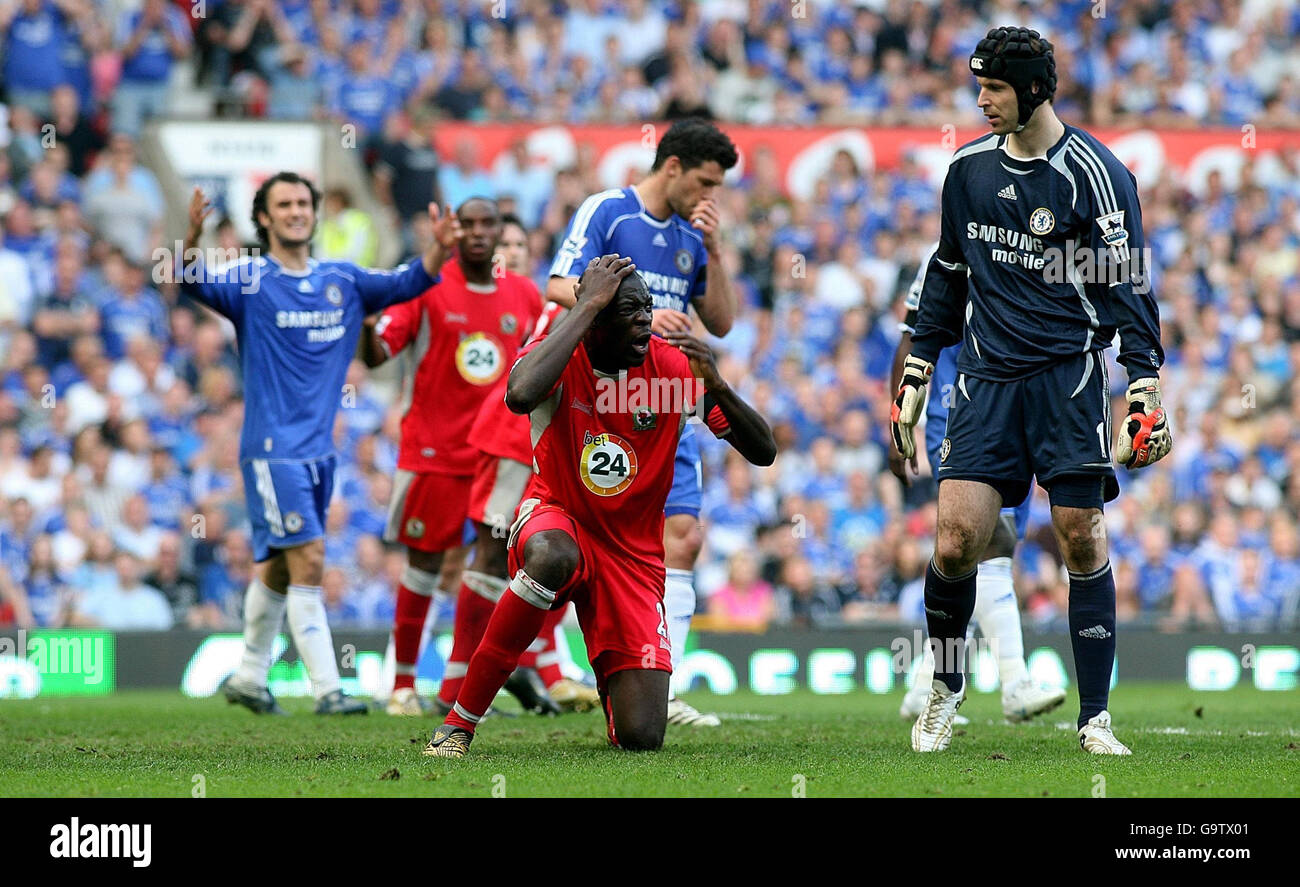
[178,172,459,714]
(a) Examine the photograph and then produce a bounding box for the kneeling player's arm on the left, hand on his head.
[506,255,636,415]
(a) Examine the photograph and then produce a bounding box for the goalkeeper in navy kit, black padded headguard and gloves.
[892,27,1171,754]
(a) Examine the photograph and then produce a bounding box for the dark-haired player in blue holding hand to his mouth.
[546,118,738,727]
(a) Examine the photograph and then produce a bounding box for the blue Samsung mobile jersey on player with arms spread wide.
[182,256,436,462]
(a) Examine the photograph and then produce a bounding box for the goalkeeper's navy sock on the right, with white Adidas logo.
[1070,561,1115,727]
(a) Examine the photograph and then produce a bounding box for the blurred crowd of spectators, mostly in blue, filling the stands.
[0,0,1300,629]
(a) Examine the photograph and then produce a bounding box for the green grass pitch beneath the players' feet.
[0,684,1300,797]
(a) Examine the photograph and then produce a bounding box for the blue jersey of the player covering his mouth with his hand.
[550,187,709,311]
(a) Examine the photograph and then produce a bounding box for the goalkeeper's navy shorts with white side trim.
[936,351,1119,506]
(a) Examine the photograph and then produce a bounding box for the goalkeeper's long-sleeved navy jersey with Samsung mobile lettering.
[913,126,1164,380]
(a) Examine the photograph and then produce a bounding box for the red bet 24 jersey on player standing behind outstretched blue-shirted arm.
[374,259,542,475]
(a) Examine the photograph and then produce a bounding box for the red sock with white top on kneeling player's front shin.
[447,570,555,732]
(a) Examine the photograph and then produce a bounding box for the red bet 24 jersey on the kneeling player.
[521,336,728,566]
